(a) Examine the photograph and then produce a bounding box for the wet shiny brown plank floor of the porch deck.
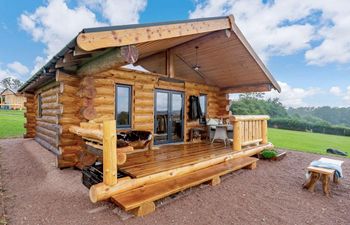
[118,143,233,178]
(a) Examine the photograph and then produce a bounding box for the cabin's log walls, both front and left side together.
[25,69,228,168]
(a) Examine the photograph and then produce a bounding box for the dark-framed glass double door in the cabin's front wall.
[154,90,184,144]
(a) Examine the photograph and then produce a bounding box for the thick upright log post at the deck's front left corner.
[103,120,117,186]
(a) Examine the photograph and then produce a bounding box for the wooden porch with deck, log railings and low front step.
[70,116,273,216]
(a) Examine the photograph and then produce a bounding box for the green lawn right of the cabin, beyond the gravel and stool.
[268,128,350,156]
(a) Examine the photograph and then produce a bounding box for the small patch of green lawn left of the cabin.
[0,110,25,138]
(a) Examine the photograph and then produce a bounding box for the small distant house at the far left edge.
[0,88,25,109]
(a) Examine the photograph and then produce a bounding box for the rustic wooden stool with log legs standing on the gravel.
[303,166,339,197]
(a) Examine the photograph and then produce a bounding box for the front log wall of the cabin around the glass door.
[81,70,229,141]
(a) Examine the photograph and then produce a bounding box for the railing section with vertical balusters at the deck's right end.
[230,115,270,151]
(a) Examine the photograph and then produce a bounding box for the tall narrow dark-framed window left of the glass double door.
[115,84,131,128]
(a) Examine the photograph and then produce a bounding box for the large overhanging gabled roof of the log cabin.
[19,16,280,92]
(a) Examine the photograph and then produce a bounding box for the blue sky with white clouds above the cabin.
[0,0,350,107]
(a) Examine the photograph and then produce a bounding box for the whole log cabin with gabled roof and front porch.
[19,15,280,216]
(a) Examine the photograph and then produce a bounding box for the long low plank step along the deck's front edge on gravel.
[111,157,258,216]
